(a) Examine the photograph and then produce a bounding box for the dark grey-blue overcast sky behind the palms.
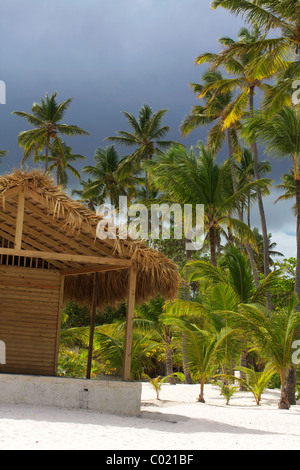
[0,0,295,256]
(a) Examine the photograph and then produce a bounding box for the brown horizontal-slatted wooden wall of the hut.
[0,265,63,375]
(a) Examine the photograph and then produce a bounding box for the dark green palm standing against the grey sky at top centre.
[107,104,172,201]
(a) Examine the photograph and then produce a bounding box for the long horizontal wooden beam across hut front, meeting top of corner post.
[0,248,132,268]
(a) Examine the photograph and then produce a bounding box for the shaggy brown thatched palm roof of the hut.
[0,170,180,306]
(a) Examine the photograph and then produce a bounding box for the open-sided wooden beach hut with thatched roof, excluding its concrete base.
[0,170,180,381]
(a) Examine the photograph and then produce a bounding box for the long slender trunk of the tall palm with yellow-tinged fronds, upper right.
[249,87,272,310]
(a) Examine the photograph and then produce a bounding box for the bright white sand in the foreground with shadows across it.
[0,384,300,450]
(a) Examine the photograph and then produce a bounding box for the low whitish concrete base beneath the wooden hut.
[0,374,142,416]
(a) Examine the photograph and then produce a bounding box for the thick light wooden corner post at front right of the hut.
[123,266,136,381]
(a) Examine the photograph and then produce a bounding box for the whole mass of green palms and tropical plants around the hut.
[0,0,300,409]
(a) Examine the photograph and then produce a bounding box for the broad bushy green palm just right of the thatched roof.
[147,142,270,266]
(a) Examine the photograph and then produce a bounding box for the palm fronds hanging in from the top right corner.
[212,0,300,114]
